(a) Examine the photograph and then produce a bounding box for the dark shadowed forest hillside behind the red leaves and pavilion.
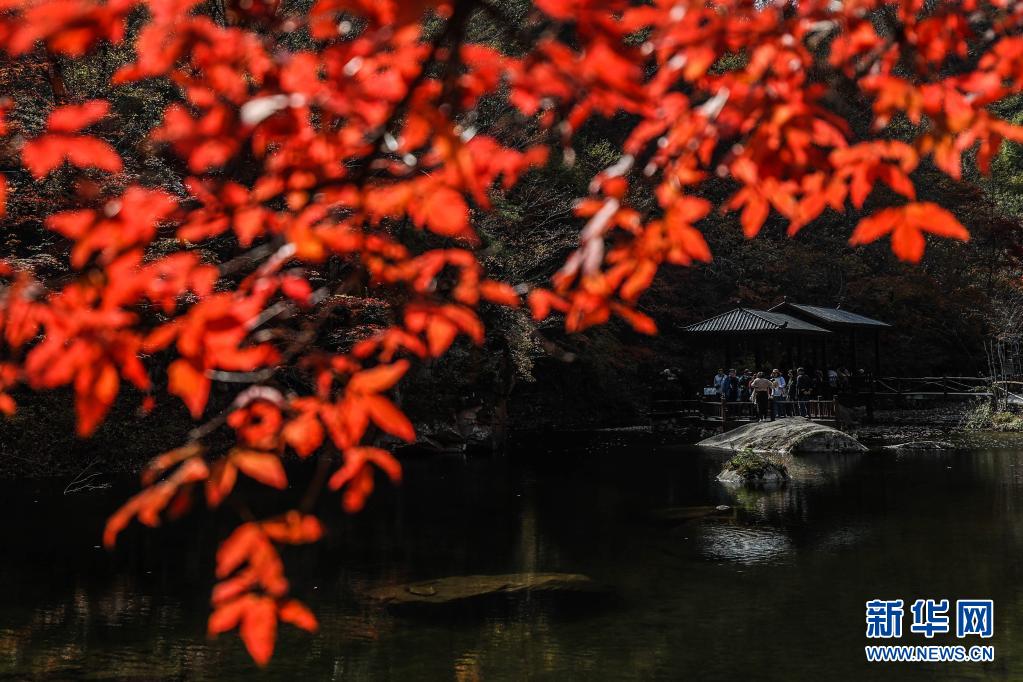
[0,2,1023,465]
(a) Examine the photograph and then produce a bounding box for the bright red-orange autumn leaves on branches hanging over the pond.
[0,0,1023,664]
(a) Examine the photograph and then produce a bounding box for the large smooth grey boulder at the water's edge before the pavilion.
[697,417,866,455]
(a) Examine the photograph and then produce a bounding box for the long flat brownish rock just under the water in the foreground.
[365,573,606,605]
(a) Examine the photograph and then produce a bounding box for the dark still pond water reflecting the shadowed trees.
[0,441,1023,680]
